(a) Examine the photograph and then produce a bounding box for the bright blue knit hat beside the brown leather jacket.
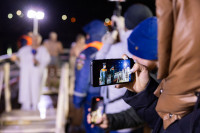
[128,17,158,60]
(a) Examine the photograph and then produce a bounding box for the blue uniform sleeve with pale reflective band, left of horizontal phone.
[73,53,90,108]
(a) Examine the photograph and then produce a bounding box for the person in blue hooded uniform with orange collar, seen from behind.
[73,20,106,133]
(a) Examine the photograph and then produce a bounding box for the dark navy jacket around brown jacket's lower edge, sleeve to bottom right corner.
[123,78,200,133]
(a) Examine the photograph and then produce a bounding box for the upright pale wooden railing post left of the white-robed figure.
[4,63,12,112]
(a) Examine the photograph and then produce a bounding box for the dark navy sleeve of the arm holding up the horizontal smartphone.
[123,78,159,129]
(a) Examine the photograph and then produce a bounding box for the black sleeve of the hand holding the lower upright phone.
[107,108,144,130]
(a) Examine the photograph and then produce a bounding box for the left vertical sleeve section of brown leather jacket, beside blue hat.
[156,0,175,79]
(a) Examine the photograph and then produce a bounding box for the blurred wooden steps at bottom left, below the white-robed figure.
[0,110,56,133]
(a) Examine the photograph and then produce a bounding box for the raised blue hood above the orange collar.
[83,20,106,42]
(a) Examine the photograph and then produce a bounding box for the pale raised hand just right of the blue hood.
[102,30,118,44]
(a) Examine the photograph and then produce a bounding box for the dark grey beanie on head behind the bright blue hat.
[124,4,153,30]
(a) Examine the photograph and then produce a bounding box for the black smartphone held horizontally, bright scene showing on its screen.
[90,58,134,87]
